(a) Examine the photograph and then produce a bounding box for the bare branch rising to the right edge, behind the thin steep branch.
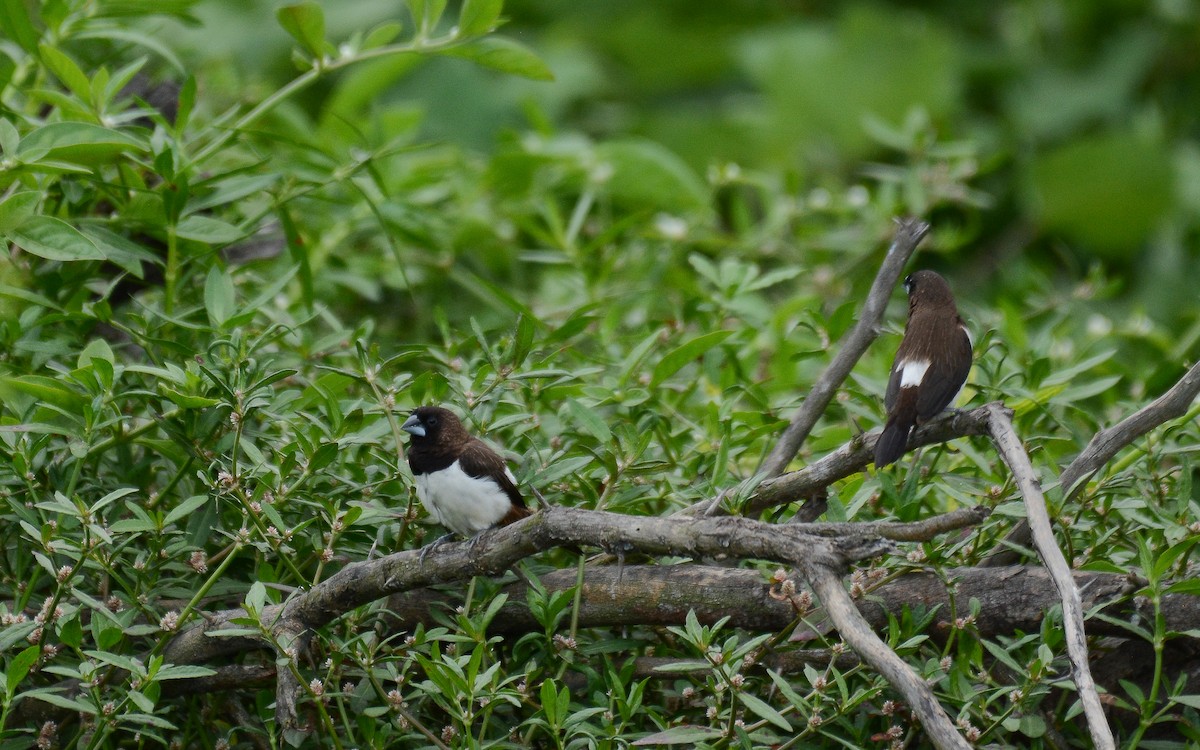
[982,362,1200,566]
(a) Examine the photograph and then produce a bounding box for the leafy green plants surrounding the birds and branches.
[0,0,1200,748]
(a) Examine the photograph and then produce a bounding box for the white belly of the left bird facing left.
[414,461,515,536]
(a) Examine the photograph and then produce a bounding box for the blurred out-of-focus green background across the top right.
[162,0,1200,307]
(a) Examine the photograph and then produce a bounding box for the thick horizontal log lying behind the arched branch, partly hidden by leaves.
[388,564,1180,640]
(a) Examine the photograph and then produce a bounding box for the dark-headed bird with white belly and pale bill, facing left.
[401,406,533,562]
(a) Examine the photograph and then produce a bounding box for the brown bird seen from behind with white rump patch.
[875,271,972,468]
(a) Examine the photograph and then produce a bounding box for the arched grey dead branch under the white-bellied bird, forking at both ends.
[152,508,982,746]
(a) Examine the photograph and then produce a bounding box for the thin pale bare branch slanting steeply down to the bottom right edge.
[990,406,1116,750]
